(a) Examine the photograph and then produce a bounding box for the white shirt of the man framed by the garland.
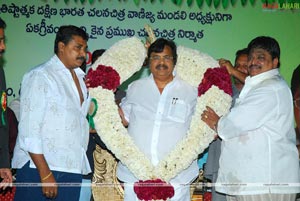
[117,75,198,184]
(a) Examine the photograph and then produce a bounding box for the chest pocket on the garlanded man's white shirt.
[167,99,189,123]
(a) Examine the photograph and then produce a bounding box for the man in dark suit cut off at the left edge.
[0,18,12,191]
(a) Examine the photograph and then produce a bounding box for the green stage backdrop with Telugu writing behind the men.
[0,0,300,101]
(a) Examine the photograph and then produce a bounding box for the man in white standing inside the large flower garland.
[117,38,198,201]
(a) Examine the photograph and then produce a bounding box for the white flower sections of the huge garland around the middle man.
[90,38,231,182]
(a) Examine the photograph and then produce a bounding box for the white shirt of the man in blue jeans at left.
[12,55,90,174]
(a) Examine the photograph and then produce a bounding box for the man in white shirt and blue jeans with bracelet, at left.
[12,25,90,201]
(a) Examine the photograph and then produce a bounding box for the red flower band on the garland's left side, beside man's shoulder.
[86,65,120,91]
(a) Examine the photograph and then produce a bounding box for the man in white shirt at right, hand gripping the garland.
[201,36,300,201]
